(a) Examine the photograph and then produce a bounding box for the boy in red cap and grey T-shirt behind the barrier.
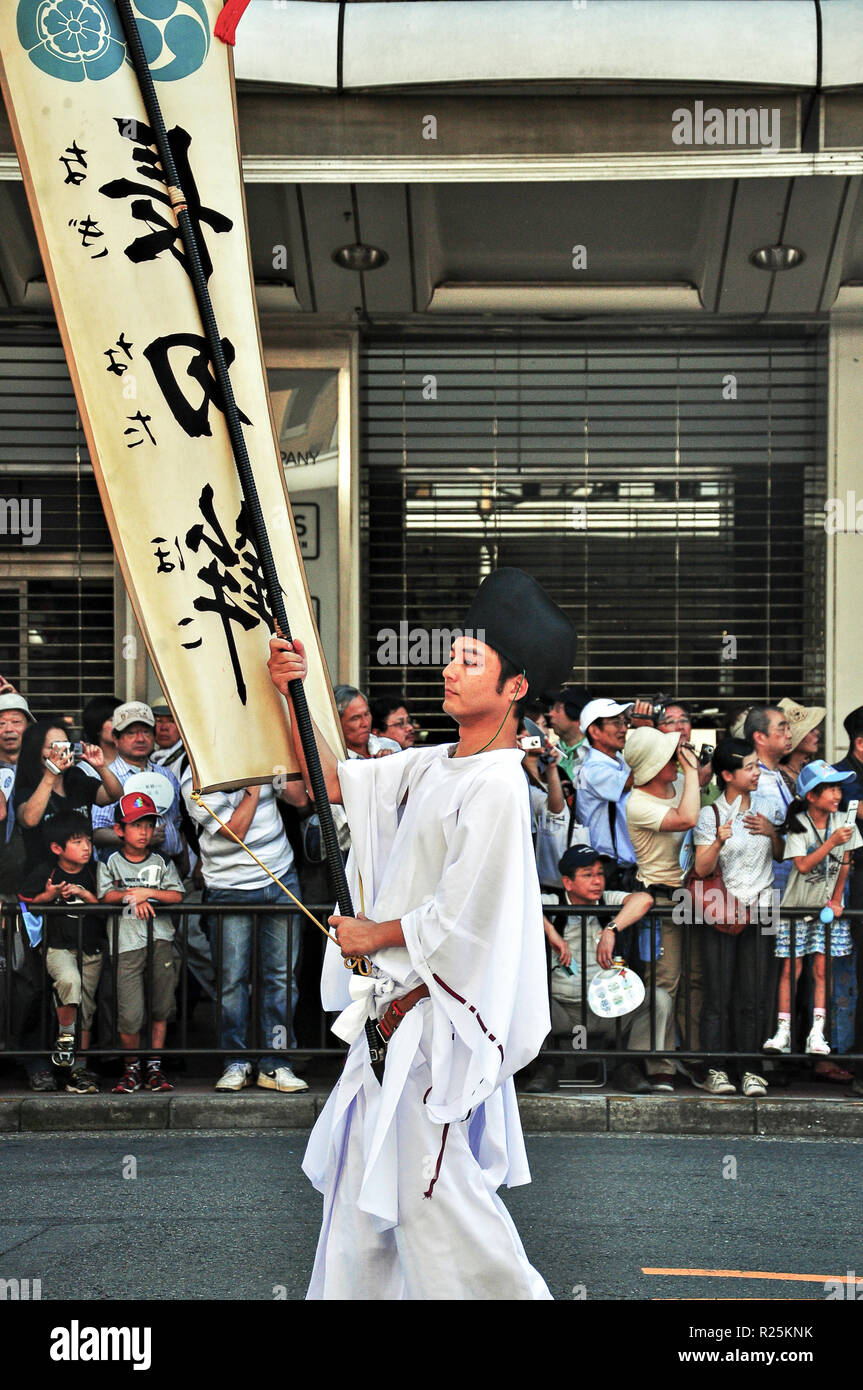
[99,792,183,1094]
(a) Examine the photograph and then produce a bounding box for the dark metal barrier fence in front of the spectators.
[0,902,863,1063]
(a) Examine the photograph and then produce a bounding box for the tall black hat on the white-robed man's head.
[464,569,578,699]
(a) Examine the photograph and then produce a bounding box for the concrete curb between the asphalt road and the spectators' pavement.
[0,1090,863,1138]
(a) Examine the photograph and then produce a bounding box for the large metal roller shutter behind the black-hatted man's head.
[361,336,827,738]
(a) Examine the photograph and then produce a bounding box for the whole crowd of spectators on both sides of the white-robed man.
[0,667,863,1095]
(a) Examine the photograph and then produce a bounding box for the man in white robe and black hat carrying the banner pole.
[270,570,575,1300]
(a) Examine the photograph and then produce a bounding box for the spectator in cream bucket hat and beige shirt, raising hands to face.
[624,728,702,1091]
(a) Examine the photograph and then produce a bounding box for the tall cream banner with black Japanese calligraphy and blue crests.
[0,0,342,790]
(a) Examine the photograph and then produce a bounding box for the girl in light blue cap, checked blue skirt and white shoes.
[764,759,863,1056]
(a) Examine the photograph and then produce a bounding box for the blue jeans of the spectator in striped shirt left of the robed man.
[207,866,300,1072]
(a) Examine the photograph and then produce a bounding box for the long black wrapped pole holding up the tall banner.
[117,0,384,1080]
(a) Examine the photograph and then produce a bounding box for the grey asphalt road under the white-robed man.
[0,1131,863,1300]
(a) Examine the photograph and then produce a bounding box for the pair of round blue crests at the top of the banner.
[18,0,210,82]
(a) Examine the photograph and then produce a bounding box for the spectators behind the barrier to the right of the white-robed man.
[525,687,863,1095]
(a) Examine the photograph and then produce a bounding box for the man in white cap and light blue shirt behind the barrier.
[575,699,635,890]
